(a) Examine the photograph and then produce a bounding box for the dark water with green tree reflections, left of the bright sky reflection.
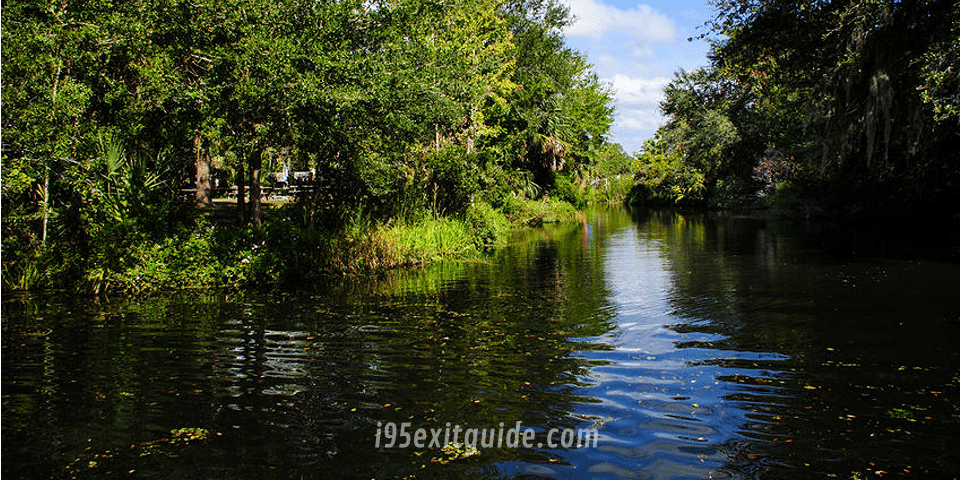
[2,219,610,478]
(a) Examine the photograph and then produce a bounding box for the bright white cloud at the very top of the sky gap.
[566,0,677,42]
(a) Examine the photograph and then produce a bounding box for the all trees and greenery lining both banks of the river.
[2,0,960,292]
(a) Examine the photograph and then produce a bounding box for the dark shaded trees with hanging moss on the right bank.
[634,0,960,219]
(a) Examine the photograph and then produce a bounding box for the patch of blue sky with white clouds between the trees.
[561,0,713,153]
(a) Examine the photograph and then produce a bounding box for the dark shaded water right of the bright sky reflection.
[637,212,960,479]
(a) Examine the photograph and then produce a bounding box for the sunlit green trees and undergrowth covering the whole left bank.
[2,0,632,292]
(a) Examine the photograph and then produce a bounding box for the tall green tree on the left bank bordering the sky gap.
[480,2,613,188]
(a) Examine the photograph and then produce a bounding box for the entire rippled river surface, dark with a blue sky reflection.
[0,211,960,479]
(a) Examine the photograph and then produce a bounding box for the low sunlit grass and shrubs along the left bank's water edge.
[3,196,582,294]
